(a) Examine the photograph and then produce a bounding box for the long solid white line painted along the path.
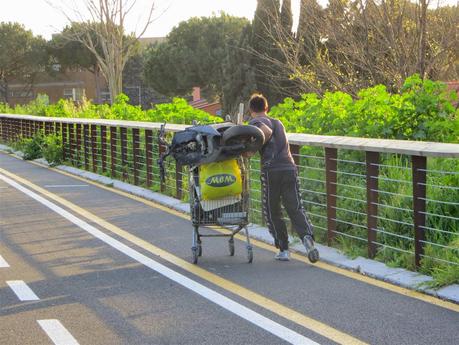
[0,174,317,345]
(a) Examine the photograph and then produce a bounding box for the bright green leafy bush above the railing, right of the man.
[270,75,459,143]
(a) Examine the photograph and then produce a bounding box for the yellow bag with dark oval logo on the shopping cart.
[199,159,242,200]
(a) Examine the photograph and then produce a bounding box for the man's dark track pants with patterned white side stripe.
[261,169,313,250]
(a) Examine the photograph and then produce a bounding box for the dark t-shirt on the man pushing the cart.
[249,116,296,170]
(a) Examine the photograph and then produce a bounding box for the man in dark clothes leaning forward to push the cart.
[249,94,319,263]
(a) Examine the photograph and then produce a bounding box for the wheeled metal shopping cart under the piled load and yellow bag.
[189,157,253,264]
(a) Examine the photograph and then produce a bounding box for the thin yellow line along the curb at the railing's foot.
[26,162,459,312]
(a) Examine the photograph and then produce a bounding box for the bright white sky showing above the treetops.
[0,0,306,39]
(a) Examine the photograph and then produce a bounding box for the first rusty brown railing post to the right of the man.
[325,147,338,246]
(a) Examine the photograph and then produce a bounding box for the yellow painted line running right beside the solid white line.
[0,168,366,344]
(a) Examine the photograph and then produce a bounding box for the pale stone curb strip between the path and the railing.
[0,145,459,304]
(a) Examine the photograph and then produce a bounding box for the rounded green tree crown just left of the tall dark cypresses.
[145,13,249,107]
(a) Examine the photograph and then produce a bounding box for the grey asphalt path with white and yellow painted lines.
[0,153,459,345]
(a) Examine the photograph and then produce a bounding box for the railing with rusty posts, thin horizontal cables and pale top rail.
[0,114,459,268]
